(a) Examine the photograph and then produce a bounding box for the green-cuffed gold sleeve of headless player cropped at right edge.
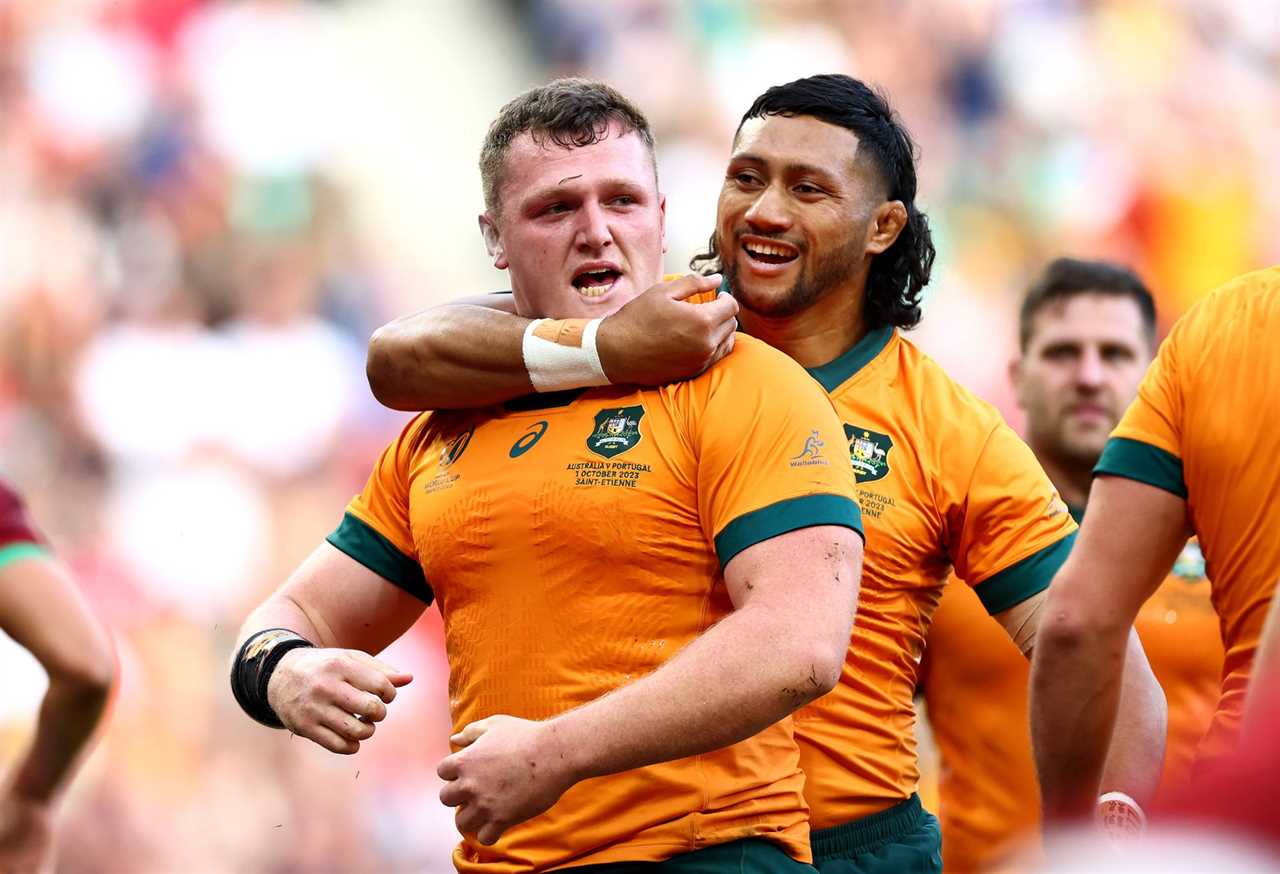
[1093,316,1188,498]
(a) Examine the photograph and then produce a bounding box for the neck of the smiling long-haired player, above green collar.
[737,289,867,367]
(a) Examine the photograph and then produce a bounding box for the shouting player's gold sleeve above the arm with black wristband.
[325,415,433,604]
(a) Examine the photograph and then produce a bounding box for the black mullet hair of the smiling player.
[690,73,934,330]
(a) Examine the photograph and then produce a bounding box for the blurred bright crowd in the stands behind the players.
[0,0,1280,874]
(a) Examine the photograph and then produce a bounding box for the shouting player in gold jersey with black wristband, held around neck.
[233,79,861,871]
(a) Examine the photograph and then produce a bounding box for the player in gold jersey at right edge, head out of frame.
[1032,267,1280,816]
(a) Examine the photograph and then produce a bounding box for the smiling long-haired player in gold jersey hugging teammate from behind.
[370,75,1165,871]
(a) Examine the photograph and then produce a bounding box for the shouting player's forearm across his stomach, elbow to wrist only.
[548,605,847,779]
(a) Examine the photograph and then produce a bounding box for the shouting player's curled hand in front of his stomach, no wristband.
[435,715,577,845]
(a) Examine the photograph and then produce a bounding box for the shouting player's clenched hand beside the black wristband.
[266,648,413,755]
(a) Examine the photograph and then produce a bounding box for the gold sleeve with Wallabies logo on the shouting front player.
[694,338,863,567]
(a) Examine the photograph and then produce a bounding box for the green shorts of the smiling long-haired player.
[810,795,942,874]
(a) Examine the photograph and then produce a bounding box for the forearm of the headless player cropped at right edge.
[1030,614,1126,820]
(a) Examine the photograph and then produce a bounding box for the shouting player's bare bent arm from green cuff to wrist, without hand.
[552,526,863,779]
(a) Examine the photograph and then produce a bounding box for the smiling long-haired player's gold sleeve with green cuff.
[948,421,1076,616]
